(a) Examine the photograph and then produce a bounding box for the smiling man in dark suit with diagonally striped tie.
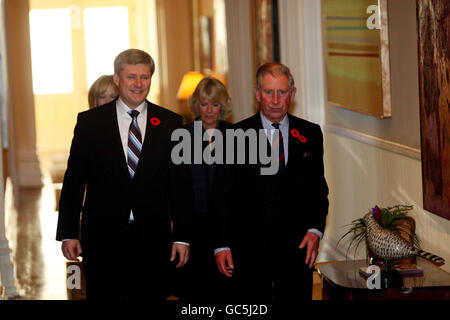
[56,49,193,303]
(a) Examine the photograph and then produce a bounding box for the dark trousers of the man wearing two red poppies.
[234,206,313,309]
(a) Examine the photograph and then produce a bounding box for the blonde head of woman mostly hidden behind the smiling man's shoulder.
[88,75,119,109]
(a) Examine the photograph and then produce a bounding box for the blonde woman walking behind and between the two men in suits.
[175,77,232,303]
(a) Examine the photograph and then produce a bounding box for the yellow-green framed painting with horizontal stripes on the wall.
[323,0,391,118]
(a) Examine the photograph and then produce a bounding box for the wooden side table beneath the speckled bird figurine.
[319,257,450,300]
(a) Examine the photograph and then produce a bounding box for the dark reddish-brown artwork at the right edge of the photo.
[417,0,450,220]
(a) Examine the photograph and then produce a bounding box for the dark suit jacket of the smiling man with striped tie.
[56,101,192,263]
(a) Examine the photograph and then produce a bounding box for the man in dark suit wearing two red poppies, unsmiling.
[213,63,328,306]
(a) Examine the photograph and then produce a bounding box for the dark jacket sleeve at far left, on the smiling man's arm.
[56,114,87,240]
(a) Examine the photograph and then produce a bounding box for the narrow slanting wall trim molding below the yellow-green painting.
[323,124,422,161]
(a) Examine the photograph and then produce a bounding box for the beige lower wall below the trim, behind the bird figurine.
[320,133,450,271]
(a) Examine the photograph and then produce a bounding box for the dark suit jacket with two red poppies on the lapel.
[213,113,328,268]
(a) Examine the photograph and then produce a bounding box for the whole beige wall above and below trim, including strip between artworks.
[319,0,450,271]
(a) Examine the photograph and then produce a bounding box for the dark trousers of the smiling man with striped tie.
[83,223,167,305]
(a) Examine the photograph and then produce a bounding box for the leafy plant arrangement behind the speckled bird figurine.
[337,205,420,256]
